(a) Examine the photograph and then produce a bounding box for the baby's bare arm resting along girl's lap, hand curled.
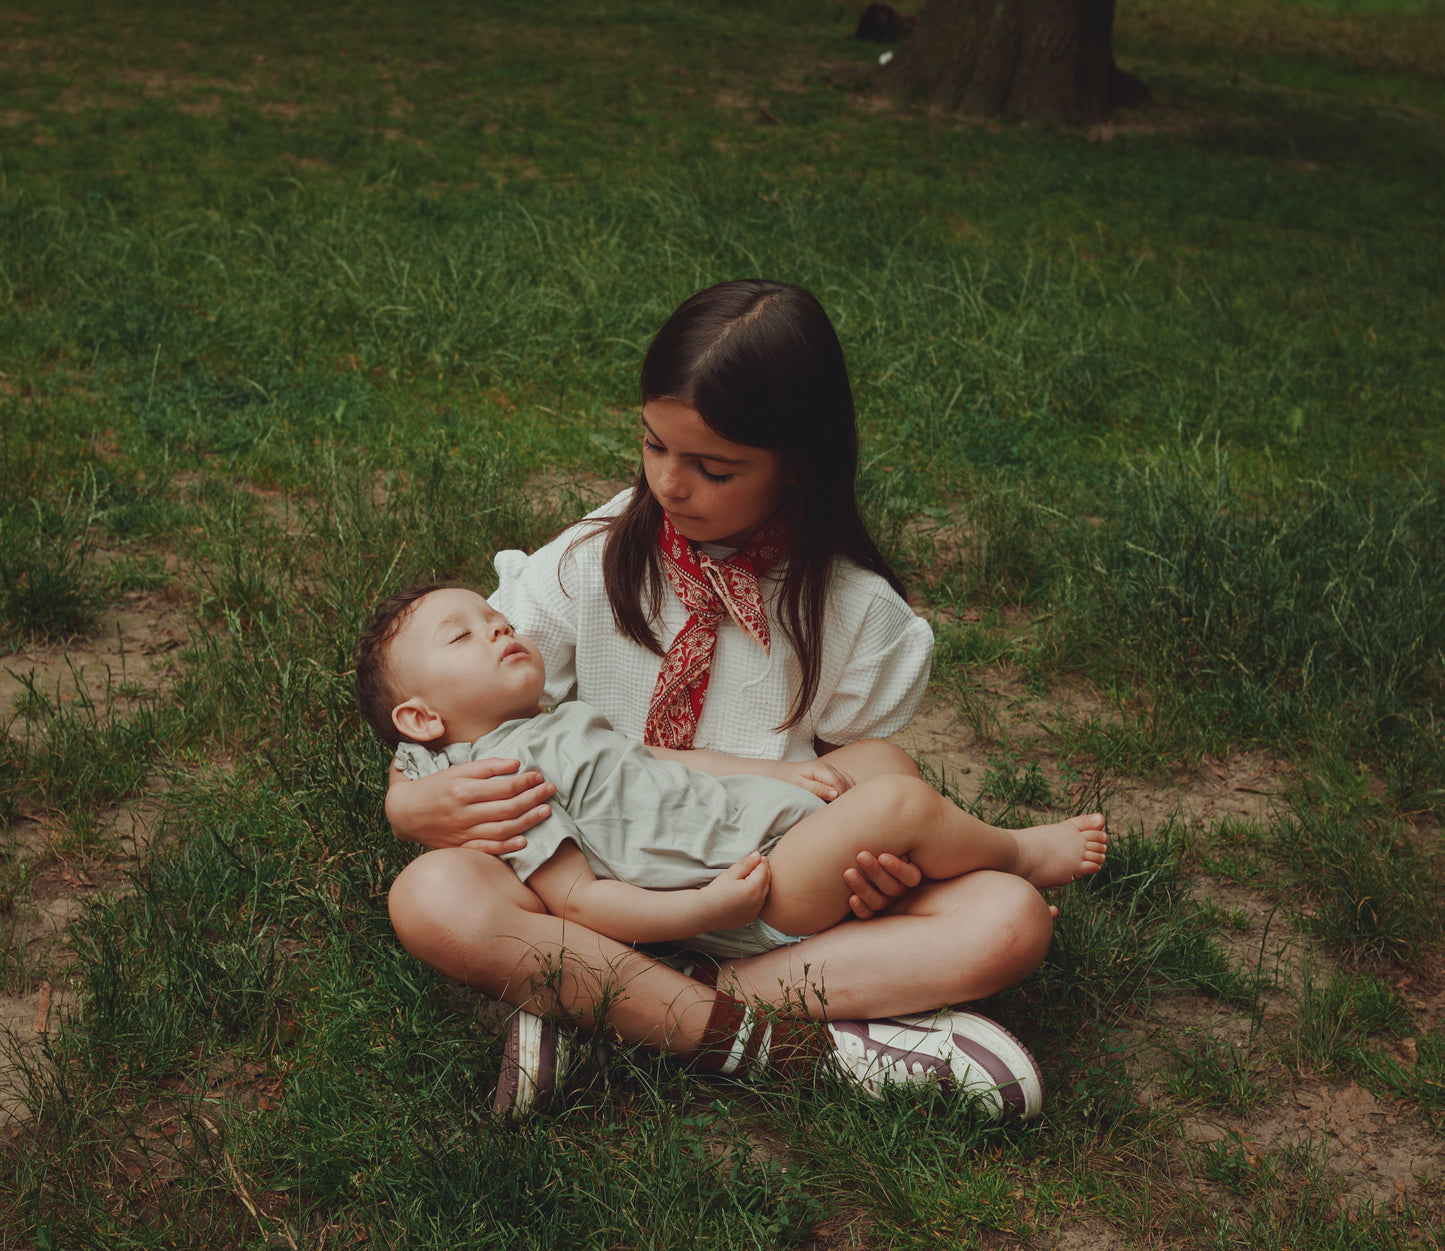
[527,841,772,943]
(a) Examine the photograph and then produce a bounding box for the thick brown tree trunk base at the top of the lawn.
[883,0,1149,126]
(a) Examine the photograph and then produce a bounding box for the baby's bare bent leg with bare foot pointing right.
[762,774,1108,935]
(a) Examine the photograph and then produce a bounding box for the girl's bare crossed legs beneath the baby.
[389,848,1053,1053]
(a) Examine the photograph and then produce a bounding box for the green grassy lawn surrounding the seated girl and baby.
[0,0,1445,1251]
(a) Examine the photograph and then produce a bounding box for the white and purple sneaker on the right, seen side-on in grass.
[827,1013,1043,1121]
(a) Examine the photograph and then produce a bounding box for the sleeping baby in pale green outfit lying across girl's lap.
[357,586,1108,958]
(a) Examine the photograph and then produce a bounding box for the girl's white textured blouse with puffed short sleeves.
[491,490,933,760]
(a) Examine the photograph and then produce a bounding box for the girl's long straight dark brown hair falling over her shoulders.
[603,279,903,728]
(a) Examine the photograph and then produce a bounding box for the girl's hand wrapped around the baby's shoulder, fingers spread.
[386,760,556,855]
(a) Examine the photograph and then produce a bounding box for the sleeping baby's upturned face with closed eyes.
[390,586,546,743]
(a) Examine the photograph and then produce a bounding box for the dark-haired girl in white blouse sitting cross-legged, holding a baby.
[387,280,1075,1115]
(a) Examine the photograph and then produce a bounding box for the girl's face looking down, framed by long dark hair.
[642,400,793,547]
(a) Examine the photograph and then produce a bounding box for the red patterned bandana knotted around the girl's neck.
[642,514,788,750]
